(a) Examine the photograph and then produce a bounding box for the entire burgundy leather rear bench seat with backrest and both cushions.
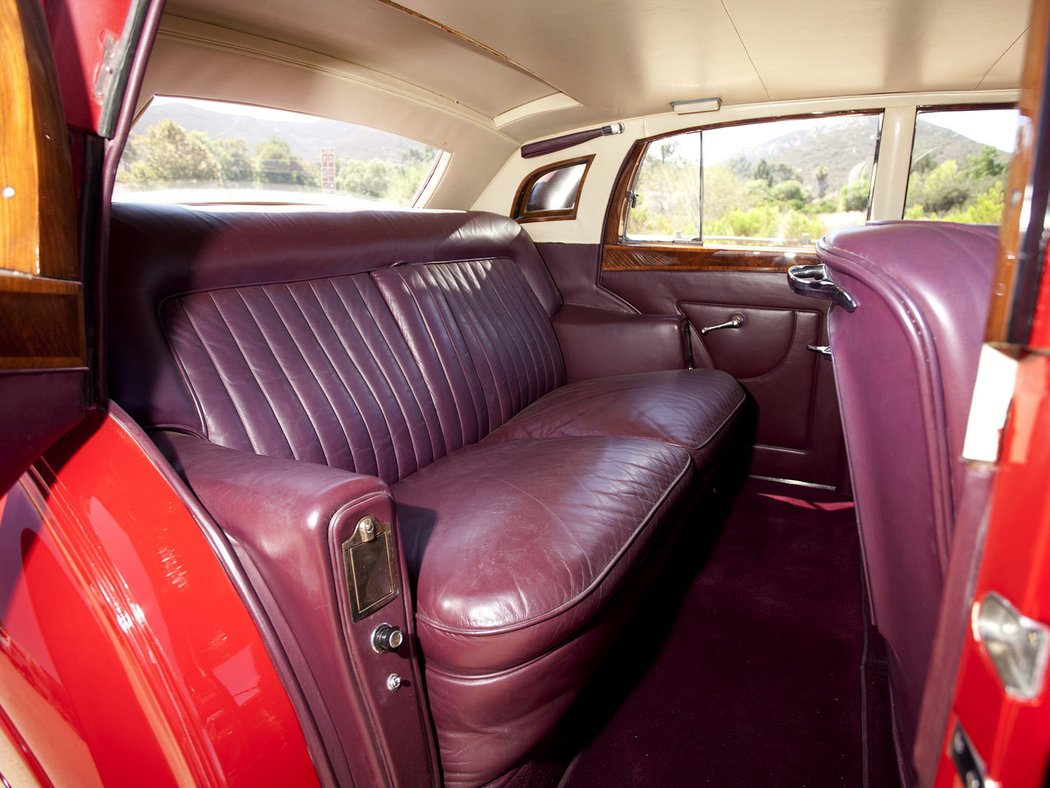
[107,206,743,784]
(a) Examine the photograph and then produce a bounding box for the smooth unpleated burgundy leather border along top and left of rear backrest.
[103,204,562,437]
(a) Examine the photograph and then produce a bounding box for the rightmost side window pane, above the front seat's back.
[904,109,1017,224]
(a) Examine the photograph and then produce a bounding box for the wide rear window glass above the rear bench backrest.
[116,97,446,208]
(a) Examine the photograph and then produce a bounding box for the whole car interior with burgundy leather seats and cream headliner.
[86,0,1032,787]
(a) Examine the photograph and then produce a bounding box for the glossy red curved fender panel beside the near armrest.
[0,412,317,786]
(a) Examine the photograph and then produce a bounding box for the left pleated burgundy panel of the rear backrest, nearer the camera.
[163,274,446,482]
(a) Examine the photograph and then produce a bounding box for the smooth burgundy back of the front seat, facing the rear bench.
[817,222,998,776]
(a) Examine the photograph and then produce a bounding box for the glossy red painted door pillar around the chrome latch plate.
[937,353,1050,788]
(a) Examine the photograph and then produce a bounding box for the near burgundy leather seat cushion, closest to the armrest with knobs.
[393,438,691,671]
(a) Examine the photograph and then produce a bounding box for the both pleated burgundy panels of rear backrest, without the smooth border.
[162,258,564,483]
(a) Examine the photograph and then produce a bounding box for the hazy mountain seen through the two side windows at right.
[726,123,1010,189]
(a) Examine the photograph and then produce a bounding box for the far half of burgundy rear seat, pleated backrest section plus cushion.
[372,260,741,470]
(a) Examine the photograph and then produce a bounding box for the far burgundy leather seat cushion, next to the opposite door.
[488,370,744,469]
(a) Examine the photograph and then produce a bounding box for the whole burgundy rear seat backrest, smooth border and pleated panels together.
[106,205,564,482]
